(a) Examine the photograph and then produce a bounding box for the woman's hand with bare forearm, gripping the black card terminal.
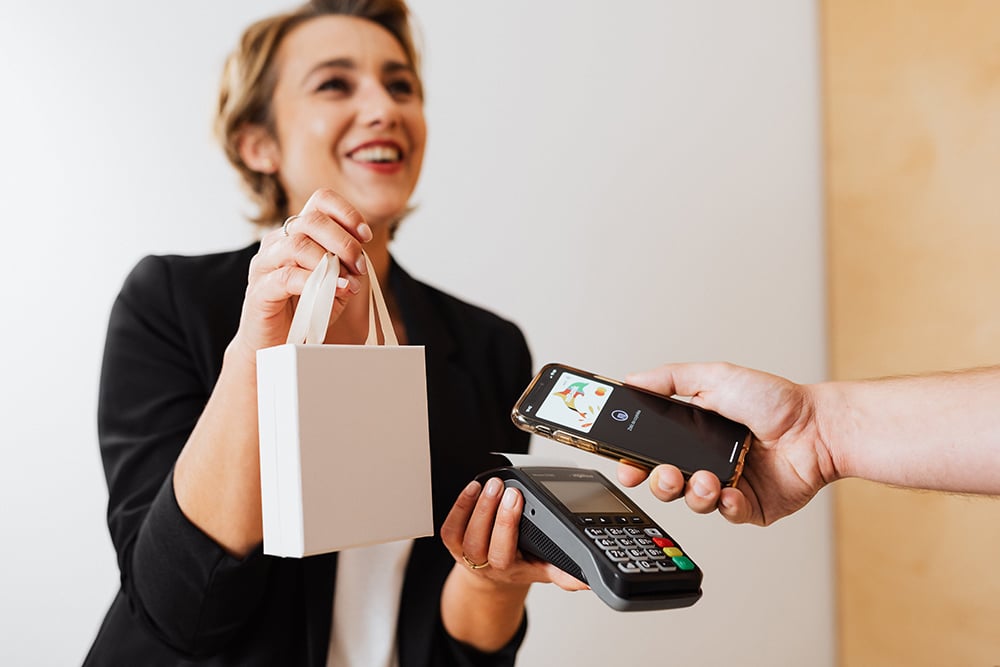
[441,477,587,651]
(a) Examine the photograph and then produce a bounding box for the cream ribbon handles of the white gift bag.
[285,252,399,345]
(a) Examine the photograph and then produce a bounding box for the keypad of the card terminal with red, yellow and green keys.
[584,517,695,574]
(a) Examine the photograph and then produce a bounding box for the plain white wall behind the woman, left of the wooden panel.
[0,0,833,665]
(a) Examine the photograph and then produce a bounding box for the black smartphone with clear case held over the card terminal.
[511,364,751,486]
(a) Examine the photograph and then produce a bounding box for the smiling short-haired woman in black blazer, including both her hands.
[86,0,582,667]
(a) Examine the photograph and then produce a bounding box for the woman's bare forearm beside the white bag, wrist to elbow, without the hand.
[174,346,263,558]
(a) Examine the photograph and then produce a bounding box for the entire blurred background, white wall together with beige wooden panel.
[0,0,1000,666]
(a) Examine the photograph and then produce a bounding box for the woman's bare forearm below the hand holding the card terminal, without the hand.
[441,565,530,652]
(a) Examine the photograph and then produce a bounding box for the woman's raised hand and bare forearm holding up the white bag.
[173,185,372,558]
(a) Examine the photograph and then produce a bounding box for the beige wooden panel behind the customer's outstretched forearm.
[821,0,1000,667]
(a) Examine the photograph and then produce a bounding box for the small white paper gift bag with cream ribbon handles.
[257,253,434,557]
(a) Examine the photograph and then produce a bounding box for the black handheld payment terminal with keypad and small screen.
[477,466,702,611]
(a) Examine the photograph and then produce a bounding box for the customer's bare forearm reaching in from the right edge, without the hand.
[810,367,1000,494]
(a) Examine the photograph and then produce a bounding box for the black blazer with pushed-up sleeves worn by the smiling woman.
[84,244,531,667]
